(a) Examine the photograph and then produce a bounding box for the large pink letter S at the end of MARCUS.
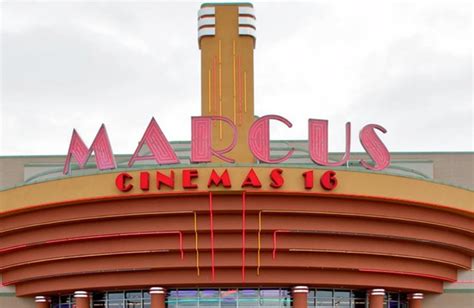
[359,124,390,171]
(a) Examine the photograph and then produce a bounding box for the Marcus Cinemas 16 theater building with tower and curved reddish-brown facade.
[0,3,474,308]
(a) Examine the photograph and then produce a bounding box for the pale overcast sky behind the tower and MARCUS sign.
[0,0,474,155]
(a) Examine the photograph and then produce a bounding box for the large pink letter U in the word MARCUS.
[308,119,351,167]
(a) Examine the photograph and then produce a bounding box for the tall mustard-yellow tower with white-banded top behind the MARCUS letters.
[198,3,256,162]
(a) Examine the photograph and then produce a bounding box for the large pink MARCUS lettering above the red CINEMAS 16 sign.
[63,115,390,174]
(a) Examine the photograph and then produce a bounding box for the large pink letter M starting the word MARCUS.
[63,124,117,174]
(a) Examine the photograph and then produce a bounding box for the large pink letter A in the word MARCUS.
[128,118,179,167]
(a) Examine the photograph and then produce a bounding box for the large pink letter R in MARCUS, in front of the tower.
[191,116,237,163]
